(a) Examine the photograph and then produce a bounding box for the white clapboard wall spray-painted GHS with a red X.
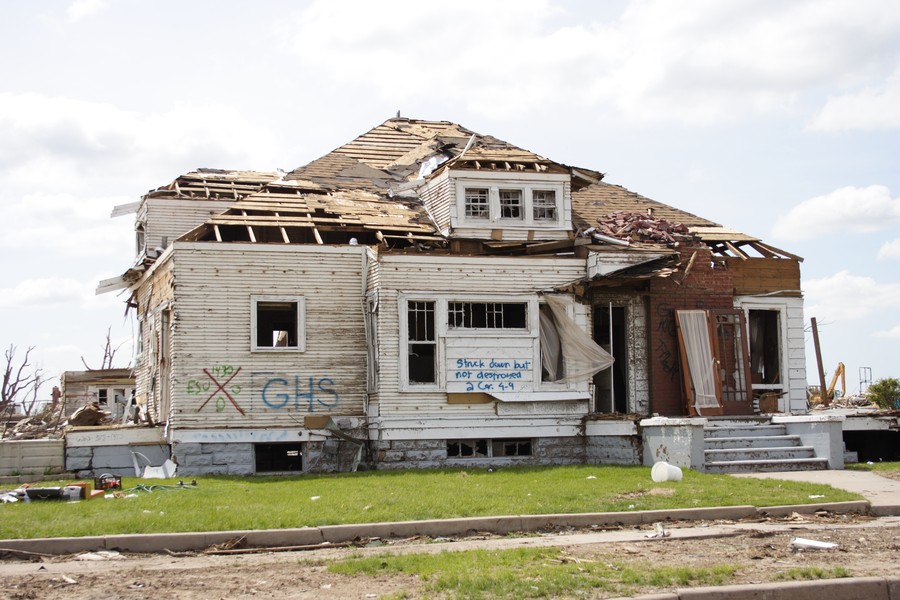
[172,242,366,428]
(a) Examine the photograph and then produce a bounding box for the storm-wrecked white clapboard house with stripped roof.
[98,118,807,475]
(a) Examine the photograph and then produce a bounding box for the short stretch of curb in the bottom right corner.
[617,577,900,600]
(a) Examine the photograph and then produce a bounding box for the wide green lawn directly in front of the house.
[0,466,861,539]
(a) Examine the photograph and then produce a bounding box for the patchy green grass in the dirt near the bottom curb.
[329,548,737,599]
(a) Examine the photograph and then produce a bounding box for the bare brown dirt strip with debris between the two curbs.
[0,514,900,600]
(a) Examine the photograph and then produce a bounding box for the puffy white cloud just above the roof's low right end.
[772,185,900,240]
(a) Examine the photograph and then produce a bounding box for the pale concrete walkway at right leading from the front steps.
[734,469,900,517]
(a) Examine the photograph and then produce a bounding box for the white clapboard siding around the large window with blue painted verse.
[377,255,589,426]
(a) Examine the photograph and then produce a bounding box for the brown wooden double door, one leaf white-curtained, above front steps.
[675,309,753,416]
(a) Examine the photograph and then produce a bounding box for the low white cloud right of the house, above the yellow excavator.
[803,271,900,321]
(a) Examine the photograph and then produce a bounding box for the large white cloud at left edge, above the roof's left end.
[0,92,285,194]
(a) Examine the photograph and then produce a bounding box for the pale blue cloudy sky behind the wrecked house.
[0,0,900,394]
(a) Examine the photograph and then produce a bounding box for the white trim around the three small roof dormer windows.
[456,178,565,229]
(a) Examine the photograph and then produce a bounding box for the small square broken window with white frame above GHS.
[251,297,306,351]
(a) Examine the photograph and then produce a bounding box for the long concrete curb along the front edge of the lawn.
[0,501,872,556]
